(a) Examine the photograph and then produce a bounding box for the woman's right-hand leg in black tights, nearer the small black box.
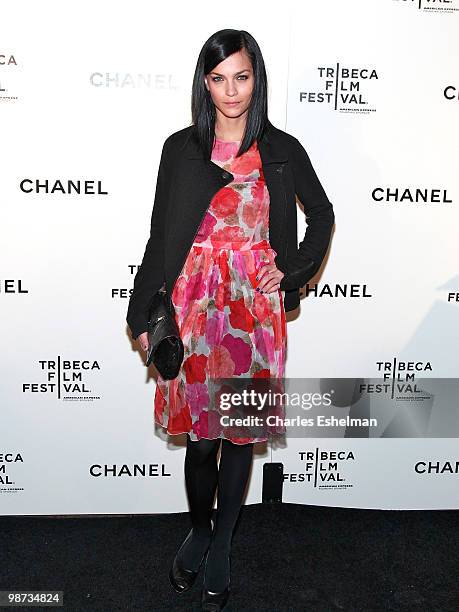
[204,439,253,592]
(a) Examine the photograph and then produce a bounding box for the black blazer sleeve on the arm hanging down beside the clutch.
[126,139,169,340]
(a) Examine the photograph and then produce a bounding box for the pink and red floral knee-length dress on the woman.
[154,139,287,444]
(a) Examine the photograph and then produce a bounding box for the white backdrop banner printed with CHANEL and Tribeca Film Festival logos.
[0,0,459,515]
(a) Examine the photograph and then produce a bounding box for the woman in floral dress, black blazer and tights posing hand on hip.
[127,29,334,610]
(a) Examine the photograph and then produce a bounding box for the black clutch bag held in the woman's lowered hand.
[146,285,183,380]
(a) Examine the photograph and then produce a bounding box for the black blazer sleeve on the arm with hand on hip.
[280,138,335,291]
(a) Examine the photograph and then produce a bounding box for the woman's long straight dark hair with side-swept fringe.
[191,29,269,159]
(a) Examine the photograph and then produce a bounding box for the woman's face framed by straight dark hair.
[204,49,254,118]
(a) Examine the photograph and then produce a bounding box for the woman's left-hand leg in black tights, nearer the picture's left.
[180,435,220,570]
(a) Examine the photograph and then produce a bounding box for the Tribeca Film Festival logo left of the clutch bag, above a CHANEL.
[22,355,100,402]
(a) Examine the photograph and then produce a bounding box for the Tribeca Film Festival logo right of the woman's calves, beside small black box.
[284,447,355,489]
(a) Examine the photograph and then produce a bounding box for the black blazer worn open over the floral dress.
[126,123,335,338]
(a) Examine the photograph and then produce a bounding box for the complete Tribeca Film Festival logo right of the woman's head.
[299,63,379,113]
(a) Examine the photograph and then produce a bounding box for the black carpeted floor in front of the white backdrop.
[0,504,459,612]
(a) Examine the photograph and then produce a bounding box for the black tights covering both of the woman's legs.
[181,435,253,591]
